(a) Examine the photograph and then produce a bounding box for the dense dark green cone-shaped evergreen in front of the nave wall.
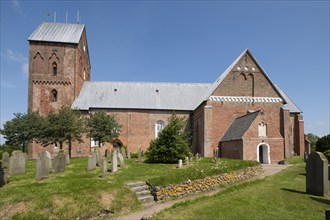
[146,114,191,163]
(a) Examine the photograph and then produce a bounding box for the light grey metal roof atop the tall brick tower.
[28,22,85,44]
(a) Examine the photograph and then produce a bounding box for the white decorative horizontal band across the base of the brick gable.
[208,96,283,102]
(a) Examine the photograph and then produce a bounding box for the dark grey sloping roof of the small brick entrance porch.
[220,111,260,141]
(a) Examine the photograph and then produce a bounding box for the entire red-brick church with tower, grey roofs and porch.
[28,22,308,163]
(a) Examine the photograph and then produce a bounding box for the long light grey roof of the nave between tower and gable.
[72,81,211,111]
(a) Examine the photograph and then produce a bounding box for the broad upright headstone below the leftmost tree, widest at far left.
[8,150,26,176]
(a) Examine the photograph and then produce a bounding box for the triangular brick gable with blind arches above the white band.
[211,50,282,98]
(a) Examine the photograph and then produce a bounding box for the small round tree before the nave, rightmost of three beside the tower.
[87,111,121,147]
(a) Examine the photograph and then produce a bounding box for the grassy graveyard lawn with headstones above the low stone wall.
[0,158,257,219]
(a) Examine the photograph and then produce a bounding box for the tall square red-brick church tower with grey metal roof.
[28,22,91,115]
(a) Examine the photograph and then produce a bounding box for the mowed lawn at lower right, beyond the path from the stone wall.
[153,161,330,220]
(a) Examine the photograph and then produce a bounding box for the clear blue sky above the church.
[0,0,330,144]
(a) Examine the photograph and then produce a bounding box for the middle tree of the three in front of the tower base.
[38,107,85,158]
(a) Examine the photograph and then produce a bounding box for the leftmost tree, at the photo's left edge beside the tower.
[0,112,45,152]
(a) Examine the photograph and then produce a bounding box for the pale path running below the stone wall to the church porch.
[113,164,291,220]
